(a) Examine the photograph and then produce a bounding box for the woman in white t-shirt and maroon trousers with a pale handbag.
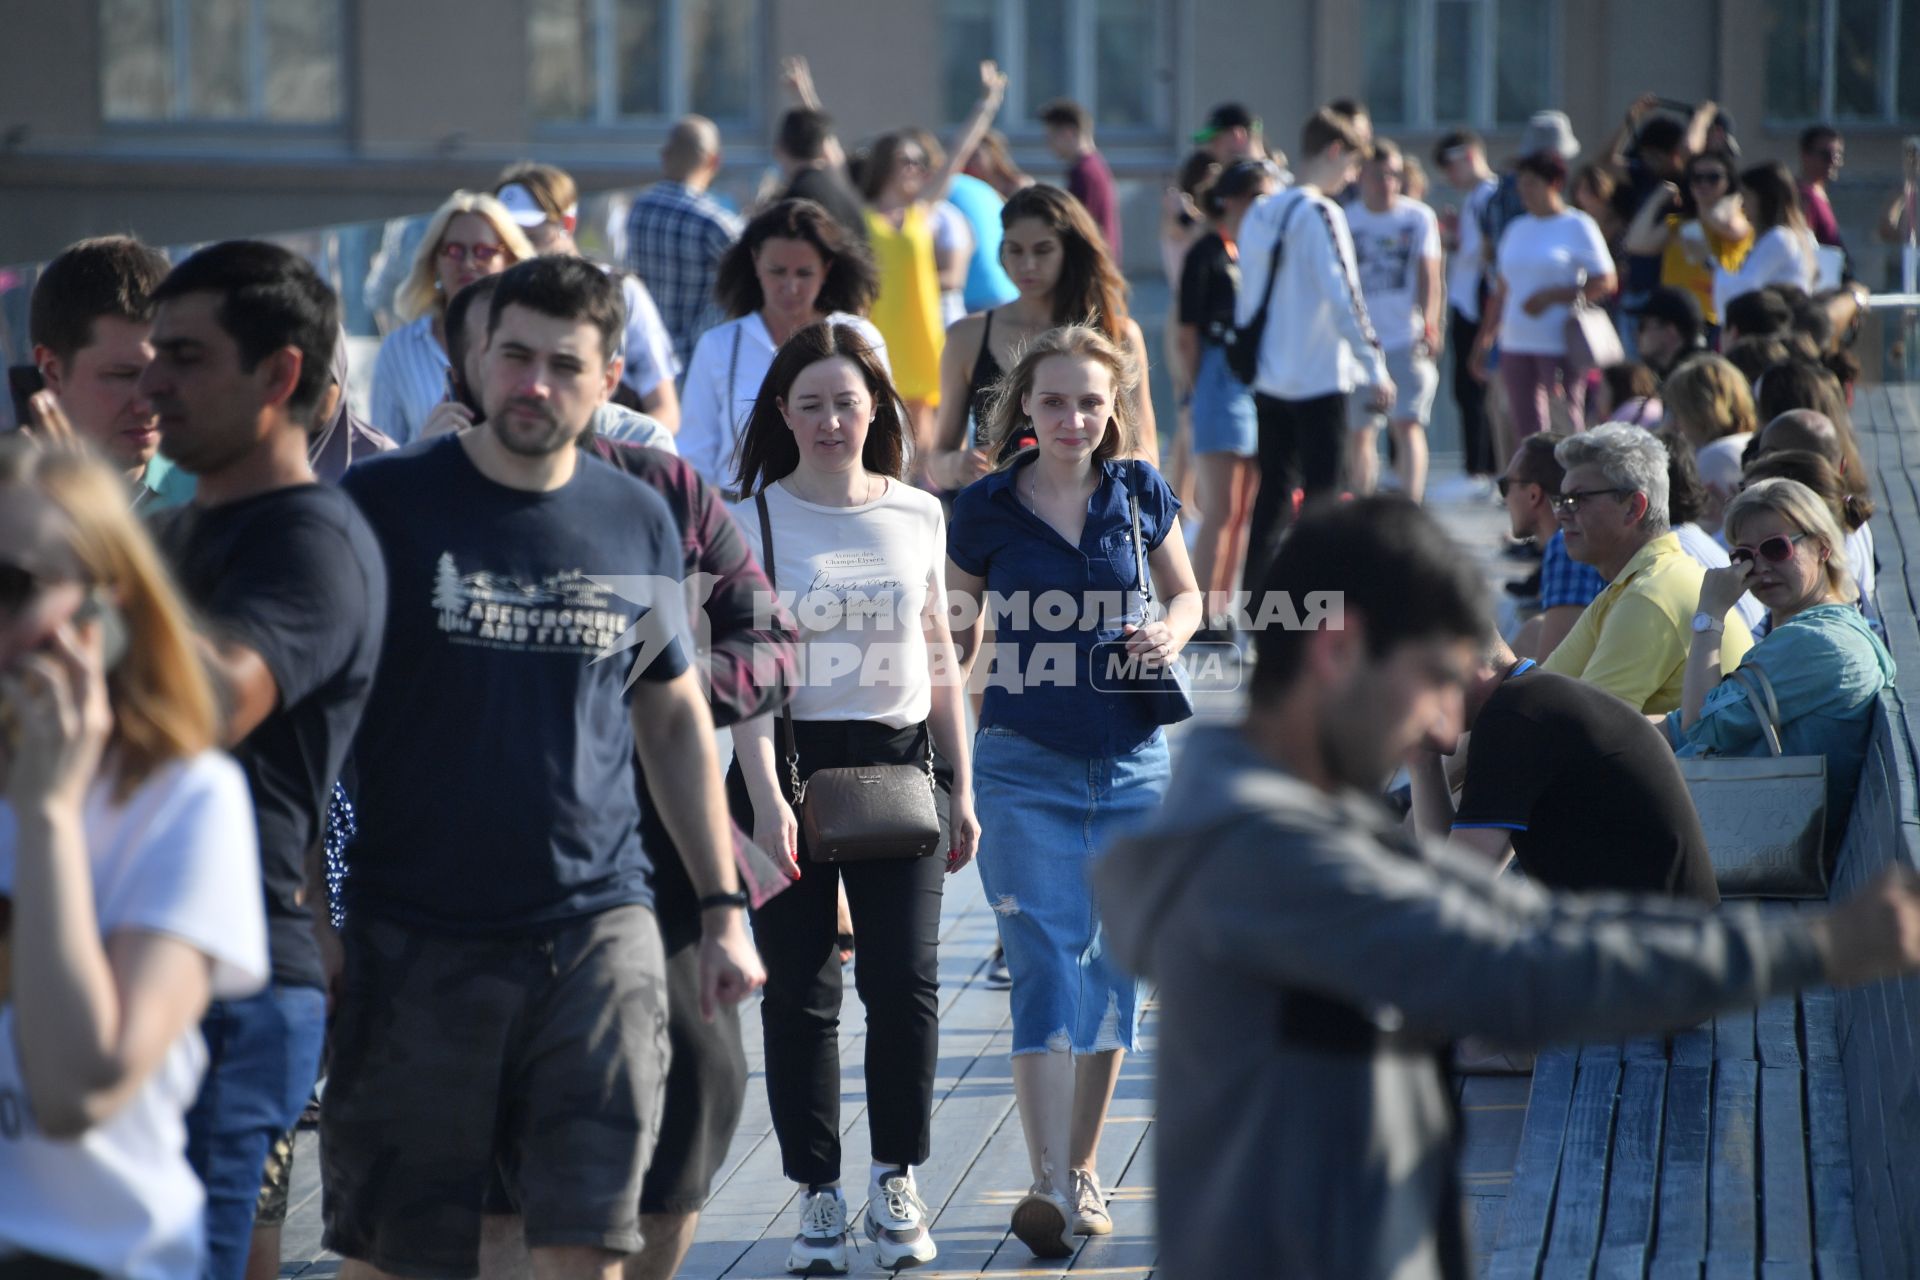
[1473,152,1617,443]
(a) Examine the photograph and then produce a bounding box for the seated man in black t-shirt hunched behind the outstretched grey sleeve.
[1409,645,1720,904]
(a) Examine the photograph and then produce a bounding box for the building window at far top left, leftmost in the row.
[98,0,342,125]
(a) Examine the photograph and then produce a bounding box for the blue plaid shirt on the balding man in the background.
[626,182,741,368]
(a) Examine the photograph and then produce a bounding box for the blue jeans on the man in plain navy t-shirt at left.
[186,983,326,1280]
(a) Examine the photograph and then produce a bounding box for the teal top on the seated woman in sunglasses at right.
[1667,604,1895,848]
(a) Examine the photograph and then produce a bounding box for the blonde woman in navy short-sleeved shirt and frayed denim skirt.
[947,326,1200,1257]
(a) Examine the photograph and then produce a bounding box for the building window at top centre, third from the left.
[941,0,1173,136]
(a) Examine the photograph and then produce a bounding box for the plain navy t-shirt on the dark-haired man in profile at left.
[154,484,386,986]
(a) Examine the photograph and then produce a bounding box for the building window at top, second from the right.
[1363,0,1555,129]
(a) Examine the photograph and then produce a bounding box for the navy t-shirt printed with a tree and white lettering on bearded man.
[342,438,687,933]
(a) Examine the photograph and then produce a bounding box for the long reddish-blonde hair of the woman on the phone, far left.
[0,443,219,798]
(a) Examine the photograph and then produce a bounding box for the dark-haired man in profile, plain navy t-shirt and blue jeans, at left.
[140,240,386,1280]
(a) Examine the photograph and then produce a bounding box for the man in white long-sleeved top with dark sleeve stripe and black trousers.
[1235,107,1394,591]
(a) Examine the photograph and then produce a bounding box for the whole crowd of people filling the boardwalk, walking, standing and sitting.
[0,59,1920,1280]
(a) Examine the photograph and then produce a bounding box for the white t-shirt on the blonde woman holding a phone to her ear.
[0,752,267,1280]
